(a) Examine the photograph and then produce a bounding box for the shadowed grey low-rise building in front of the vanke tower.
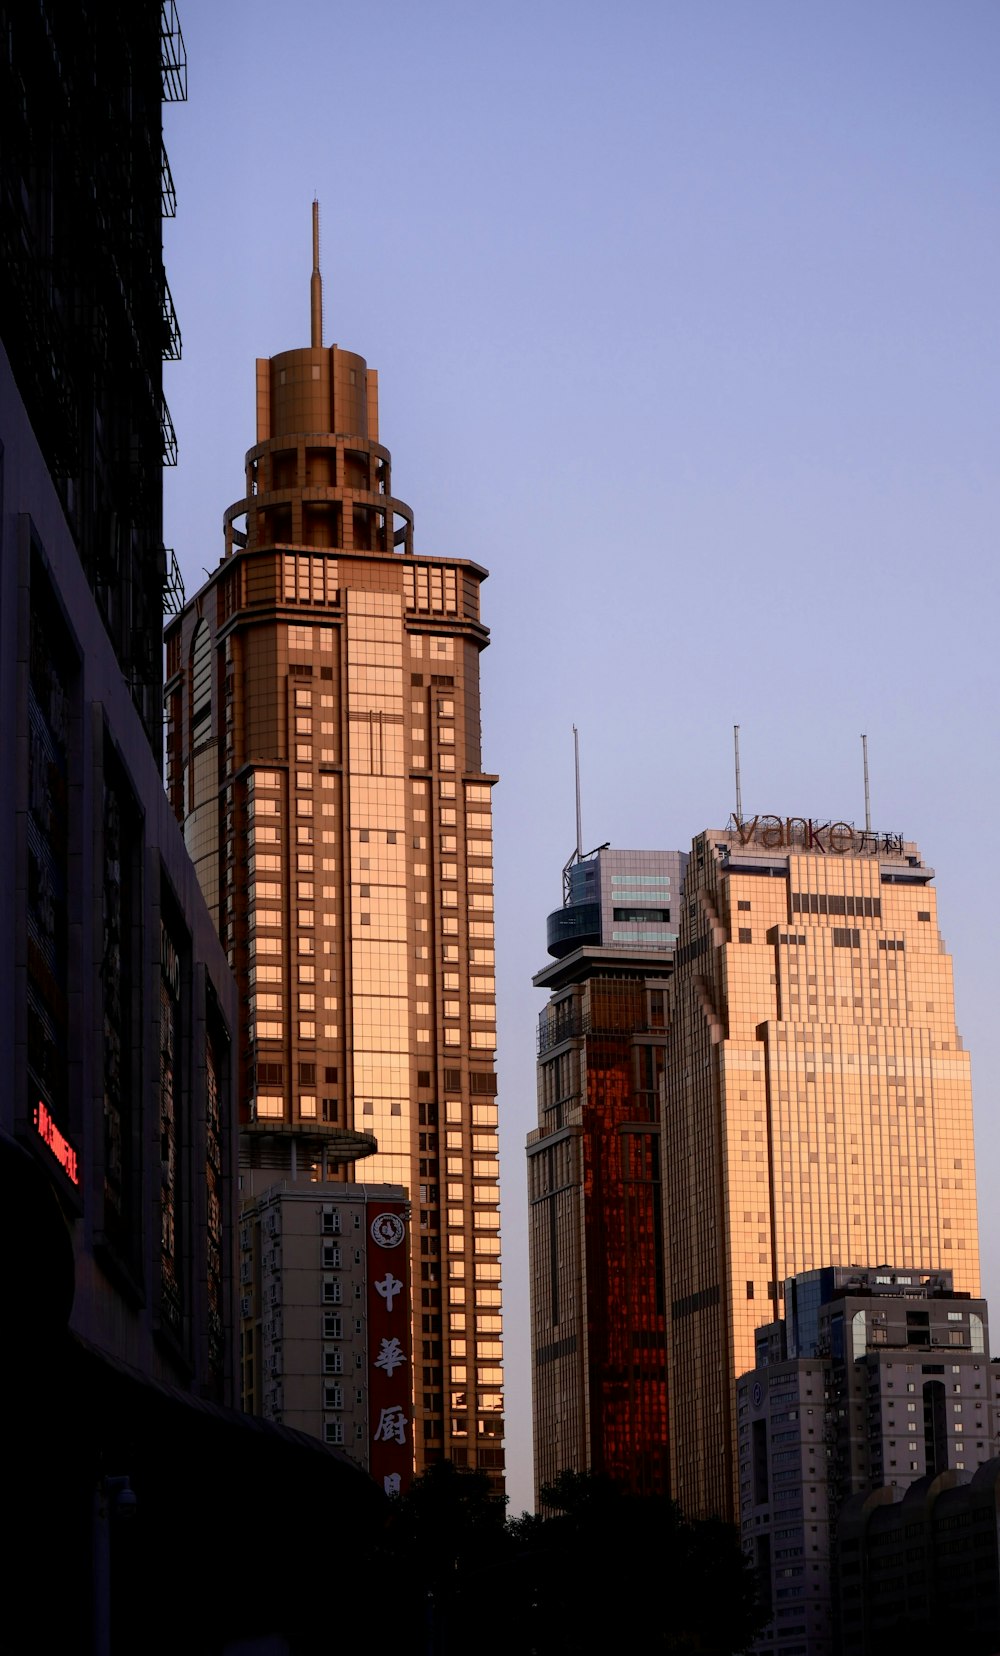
[737,1265,998,1656]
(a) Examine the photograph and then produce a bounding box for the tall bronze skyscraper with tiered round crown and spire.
[166,204,503,1484]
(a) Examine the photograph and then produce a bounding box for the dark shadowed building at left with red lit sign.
[0,0,389,1656]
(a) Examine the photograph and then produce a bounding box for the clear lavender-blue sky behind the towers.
[164,0,1000,1512]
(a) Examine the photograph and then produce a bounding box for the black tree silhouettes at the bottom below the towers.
[377,1461,767,1656]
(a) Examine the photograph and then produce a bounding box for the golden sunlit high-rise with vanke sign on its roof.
[664,816,978,1517]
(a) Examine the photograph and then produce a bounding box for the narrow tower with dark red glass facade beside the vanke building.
[528,848,685,1494]
